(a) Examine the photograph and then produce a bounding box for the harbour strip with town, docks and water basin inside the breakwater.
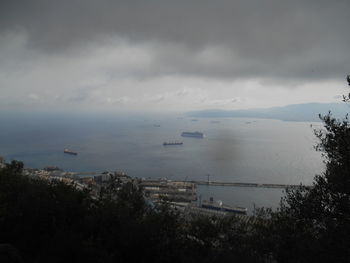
[15,166,290,216]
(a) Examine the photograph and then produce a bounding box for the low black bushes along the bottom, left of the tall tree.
[0,161,260,262]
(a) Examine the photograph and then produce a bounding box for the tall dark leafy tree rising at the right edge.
[272,76,350,262]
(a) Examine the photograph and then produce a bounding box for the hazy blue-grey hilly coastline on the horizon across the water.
[186,103,350,121]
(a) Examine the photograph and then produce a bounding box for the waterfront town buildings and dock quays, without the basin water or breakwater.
[0,157,249,220]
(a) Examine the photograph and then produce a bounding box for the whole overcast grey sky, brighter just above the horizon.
[0,0,350,112]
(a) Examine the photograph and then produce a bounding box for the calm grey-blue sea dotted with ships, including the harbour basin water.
[0,113,324,213]
